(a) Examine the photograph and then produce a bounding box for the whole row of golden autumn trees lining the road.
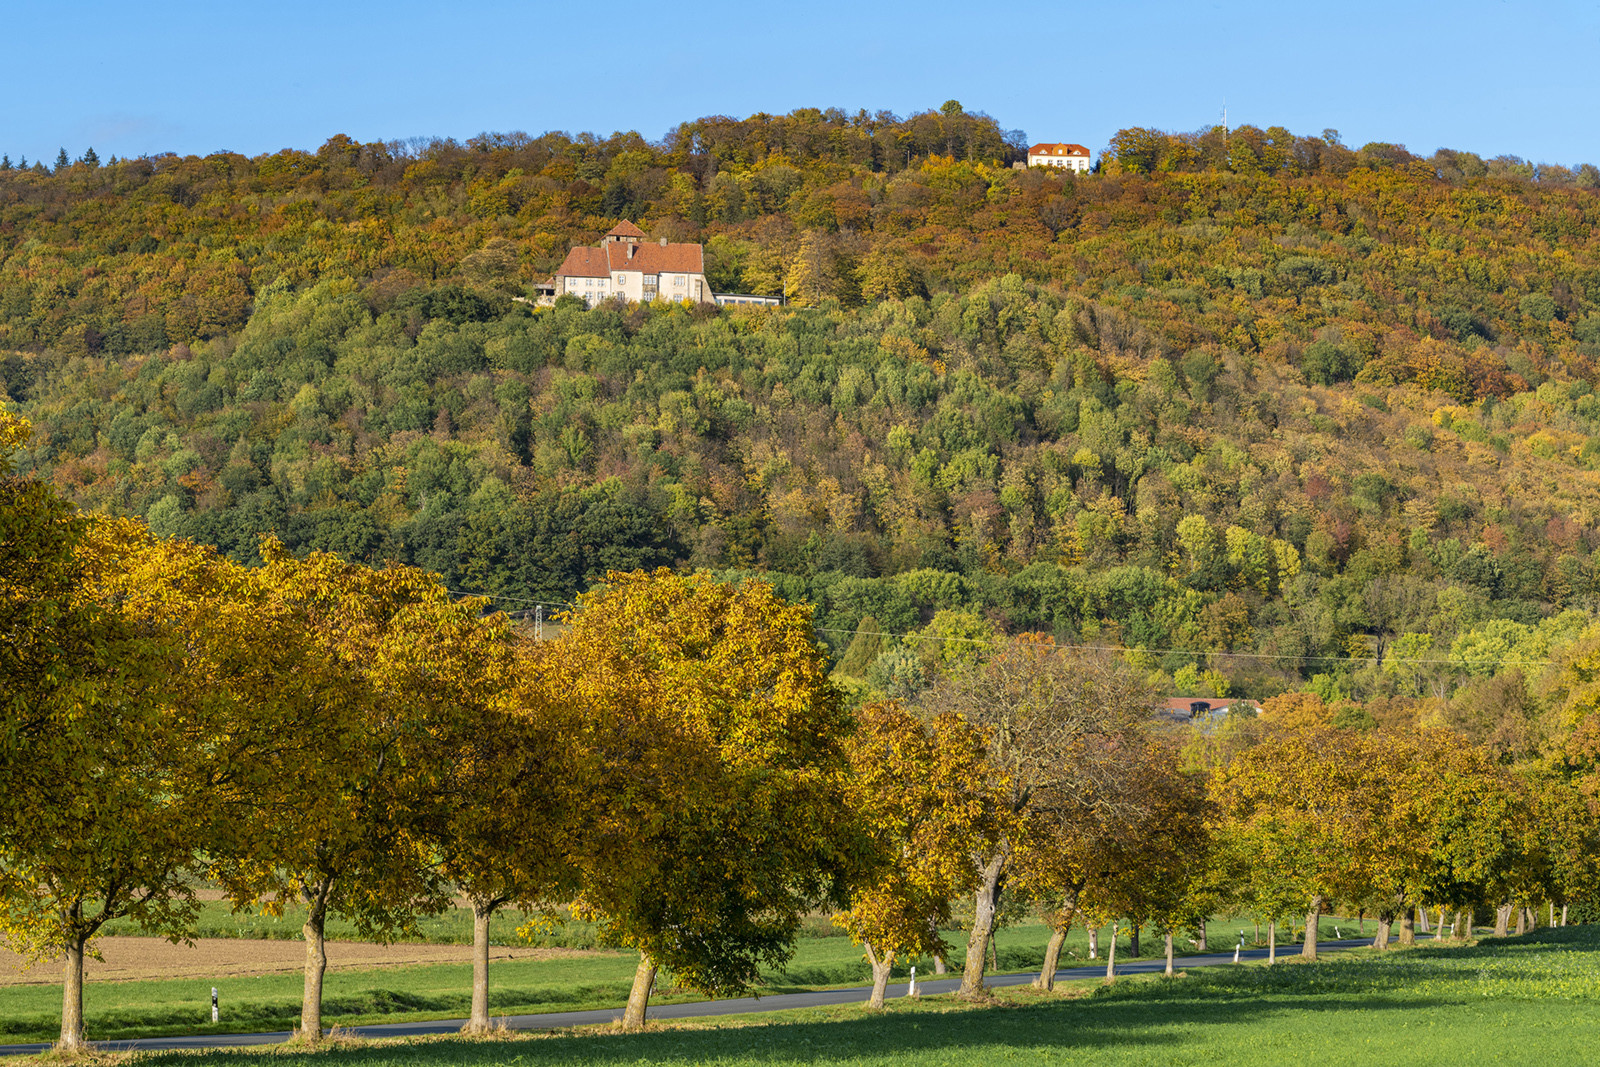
[9,414,1600,1046]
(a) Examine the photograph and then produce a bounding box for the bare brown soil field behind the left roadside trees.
[0,937,592,985]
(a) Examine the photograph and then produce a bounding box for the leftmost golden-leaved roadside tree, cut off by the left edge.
[0,444,222,1049]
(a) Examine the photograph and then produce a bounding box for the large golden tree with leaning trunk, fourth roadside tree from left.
[547,569,864,1029]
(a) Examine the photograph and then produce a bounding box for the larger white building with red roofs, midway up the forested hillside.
[539,221,715,307]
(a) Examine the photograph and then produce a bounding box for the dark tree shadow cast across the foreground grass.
[128,981,1450,1067]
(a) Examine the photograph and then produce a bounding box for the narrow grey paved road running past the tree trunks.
[0,937,1371,1056]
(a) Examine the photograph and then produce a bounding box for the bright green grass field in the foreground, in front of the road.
[109,926,1600,1067]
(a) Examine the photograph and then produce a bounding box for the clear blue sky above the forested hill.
[0,0,1600,165]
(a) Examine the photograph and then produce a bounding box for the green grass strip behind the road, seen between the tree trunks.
[0,918,1350,1043]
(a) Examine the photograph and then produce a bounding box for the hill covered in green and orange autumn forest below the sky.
[0,102,1600,716]
